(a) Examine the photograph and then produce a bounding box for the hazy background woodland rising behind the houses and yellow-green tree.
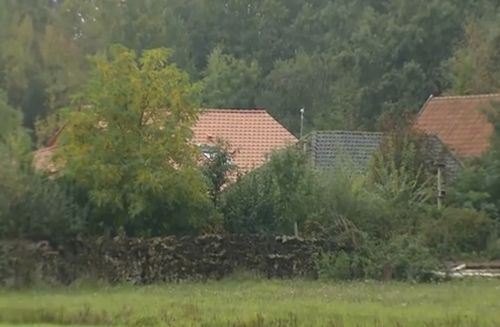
[0,0,499,131]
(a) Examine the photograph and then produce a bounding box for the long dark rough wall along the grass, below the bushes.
[0,235,338,285]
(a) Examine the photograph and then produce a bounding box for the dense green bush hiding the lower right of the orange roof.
[221,147,313,233]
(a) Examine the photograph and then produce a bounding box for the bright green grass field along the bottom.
[0,279,500,327]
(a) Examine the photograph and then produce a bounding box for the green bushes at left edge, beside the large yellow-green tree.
[0,93,86,242]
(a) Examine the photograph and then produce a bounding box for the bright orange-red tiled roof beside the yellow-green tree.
[193,109,298,172]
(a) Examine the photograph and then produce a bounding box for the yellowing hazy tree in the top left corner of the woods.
[0,0,87,127]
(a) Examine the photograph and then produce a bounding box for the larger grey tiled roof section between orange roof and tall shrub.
[307,131,383,170]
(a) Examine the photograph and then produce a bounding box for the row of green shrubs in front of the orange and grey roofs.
[221,128,438,246]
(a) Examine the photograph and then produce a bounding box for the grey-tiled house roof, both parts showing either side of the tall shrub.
[306,131,462,181]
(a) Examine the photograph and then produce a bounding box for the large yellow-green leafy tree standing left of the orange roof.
[55,46,207,235]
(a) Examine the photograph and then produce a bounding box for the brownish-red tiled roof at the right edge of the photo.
[415,94,500,157]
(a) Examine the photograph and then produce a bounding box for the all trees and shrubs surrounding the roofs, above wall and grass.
[0,0,500,279]
